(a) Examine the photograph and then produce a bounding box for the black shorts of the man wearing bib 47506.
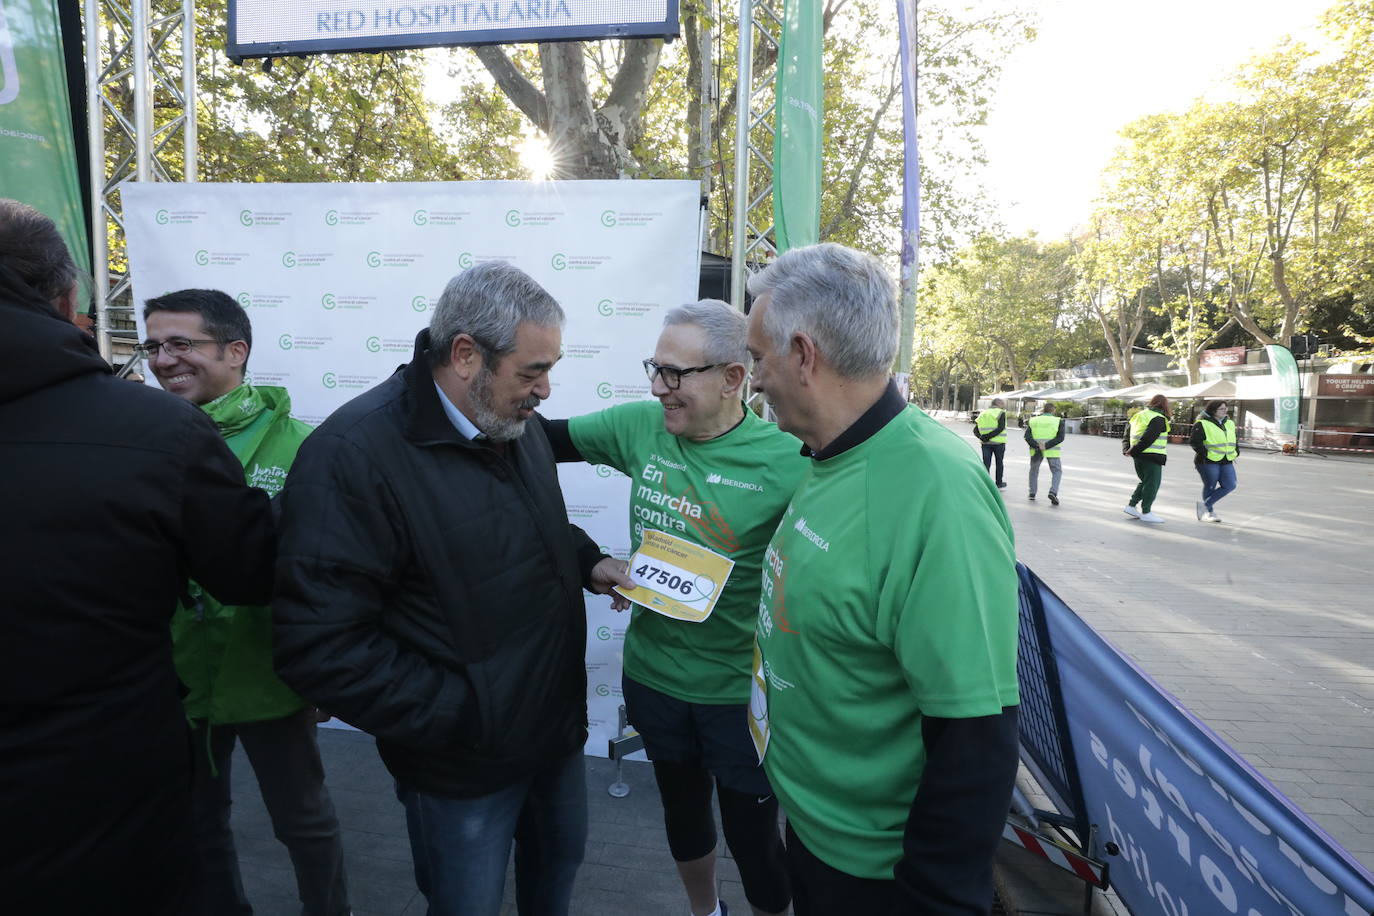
[621,676,772,797]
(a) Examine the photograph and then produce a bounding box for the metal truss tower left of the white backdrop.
[85,0,198,360]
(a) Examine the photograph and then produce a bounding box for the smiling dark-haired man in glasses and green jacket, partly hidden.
[142,290,349,916]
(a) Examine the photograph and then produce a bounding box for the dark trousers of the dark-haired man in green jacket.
[192,707,349,916]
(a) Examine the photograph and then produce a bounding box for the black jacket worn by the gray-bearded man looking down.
[272,331,603,798]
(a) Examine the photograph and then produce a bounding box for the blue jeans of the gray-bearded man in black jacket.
[396,748,587,916]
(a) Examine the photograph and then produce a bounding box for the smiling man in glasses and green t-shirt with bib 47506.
[550,299,807,916]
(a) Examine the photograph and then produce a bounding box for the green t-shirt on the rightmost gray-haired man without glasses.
[753,407,1018,879]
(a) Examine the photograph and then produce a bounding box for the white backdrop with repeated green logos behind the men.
[122,181,701,757]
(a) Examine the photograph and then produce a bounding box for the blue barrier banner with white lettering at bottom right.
[1022,571,1374,916]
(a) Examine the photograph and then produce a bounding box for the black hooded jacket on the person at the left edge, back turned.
[0,264,275,916]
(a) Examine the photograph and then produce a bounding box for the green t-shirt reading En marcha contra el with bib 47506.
[567,401,802,705]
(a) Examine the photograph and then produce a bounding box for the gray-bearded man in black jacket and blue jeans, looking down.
[272,262,632,916]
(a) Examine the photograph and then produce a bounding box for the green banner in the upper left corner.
[0,0,91,282]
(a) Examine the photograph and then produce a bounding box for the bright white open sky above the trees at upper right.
[984,0,1334,239]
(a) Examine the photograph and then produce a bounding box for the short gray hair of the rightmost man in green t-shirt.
[749,242,897,379]
